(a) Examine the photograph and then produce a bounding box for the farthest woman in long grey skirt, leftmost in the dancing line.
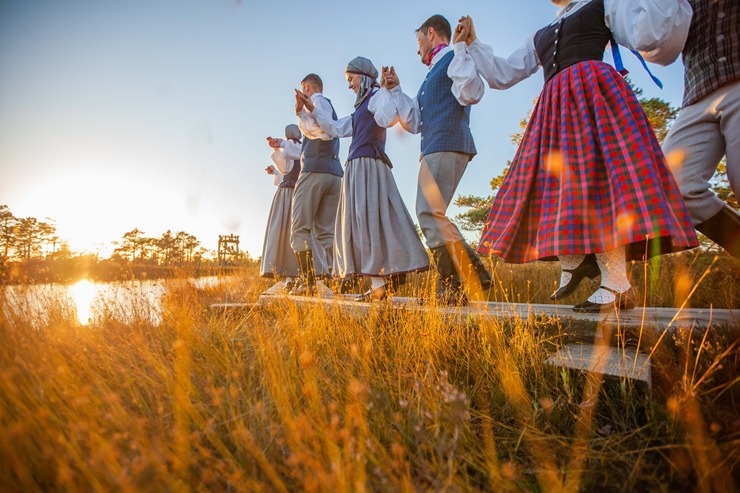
[260,124,328,290]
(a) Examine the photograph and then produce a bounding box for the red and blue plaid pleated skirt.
[478,61,698,263]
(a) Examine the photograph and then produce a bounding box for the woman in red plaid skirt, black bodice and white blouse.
[454,0,698,312]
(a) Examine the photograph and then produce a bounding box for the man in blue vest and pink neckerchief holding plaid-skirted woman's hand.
[381,15,491,305]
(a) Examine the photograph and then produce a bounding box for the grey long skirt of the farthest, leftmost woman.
[260,187,329,278]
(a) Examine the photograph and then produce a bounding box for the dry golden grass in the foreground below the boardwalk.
[0,260,740,492]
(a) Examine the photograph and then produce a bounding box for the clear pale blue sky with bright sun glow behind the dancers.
[0,0,682,257]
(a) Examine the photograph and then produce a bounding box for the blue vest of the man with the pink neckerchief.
[416,51,477,157]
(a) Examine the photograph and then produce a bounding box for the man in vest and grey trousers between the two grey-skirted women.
[270,74,344,296]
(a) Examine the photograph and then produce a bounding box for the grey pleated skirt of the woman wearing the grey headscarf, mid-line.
[334,157,429,277]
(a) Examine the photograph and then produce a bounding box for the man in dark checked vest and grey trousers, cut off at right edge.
[645,0,740,258]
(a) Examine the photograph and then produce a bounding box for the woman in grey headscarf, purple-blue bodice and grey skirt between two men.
[304,57,429,301]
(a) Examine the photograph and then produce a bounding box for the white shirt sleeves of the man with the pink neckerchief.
[371,42,485,134]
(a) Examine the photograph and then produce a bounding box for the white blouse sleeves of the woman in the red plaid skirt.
[468,0,691,89]
